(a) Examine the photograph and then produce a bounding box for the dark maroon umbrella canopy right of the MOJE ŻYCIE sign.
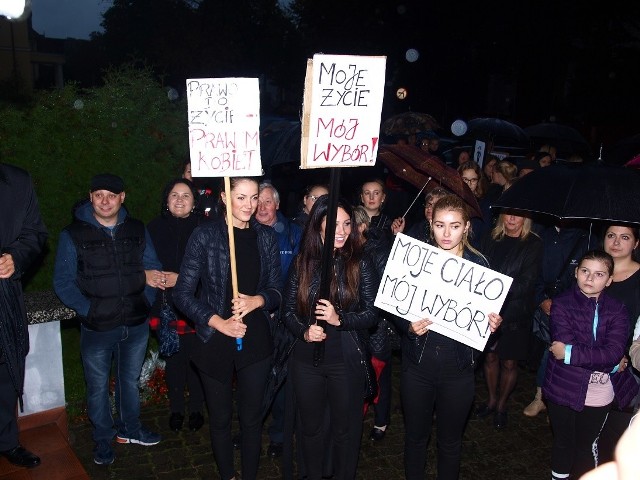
[378,145,482,217]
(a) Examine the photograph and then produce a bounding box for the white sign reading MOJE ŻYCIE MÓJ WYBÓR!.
[300,55,386,168]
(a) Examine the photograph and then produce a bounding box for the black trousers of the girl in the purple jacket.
[547,401,611,478]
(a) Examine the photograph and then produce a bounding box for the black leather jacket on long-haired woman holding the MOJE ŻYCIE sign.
[282,255,380,365]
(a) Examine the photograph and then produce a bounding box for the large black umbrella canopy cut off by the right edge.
[491,165,640,223]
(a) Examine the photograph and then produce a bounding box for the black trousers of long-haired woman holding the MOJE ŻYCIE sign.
[289,361,364,480]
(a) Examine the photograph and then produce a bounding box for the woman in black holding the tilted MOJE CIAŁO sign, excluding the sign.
[392,195,502,480]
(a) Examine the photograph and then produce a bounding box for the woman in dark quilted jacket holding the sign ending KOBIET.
[173,177,281,480]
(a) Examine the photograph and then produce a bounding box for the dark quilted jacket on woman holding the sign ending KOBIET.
[173,218,282,342]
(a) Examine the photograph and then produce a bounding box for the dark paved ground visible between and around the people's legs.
[70,354,551,480]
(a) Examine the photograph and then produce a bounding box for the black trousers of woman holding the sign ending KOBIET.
[200,357,271,480]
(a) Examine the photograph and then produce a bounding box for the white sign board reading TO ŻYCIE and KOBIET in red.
[187,78,262,177]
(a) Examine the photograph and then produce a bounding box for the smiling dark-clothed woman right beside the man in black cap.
[147,178,205,432]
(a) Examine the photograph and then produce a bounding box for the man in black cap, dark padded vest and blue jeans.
[53,174,166,465]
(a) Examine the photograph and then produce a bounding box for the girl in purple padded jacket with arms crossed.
[543,250,638,480]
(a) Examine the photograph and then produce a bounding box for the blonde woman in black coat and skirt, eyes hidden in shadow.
[476,213,542,429]
